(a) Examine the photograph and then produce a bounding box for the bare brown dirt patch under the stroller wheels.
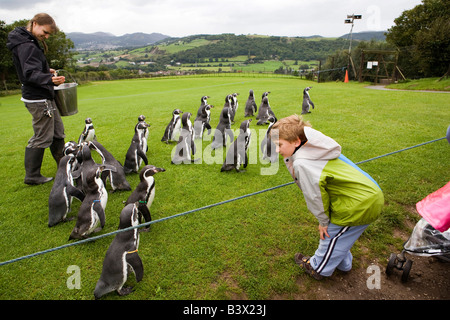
[273,238,450,300]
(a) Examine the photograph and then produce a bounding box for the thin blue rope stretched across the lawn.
[0,137,445,266]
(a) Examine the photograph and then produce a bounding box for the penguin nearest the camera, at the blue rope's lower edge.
[94,202,144,299]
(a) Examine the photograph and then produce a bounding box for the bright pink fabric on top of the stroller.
[416,182,450,232]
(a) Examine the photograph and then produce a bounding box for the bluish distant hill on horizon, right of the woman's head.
[66,32,169,50]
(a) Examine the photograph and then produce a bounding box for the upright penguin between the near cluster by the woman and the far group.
[123,120,150,174]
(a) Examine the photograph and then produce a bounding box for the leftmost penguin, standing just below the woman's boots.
[48,153,84,227]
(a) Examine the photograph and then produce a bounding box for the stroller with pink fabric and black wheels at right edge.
[386,182,450,282]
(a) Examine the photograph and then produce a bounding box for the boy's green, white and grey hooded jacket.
[285,127,384,226]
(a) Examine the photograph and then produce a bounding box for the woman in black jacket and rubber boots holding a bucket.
[6,13,65,185]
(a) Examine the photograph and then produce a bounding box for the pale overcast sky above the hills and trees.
[0,0,422,37]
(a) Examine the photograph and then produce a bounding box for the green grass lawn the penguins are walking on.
[0,77,450,300]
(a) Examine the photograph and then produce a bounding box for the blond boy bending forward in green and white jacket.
[271,115,384,280]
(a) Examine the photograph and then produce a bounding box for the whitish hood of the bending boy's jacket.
[292,127,341,160]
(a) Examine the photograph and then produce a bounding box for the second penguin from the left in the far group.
[172,112,197,164]
